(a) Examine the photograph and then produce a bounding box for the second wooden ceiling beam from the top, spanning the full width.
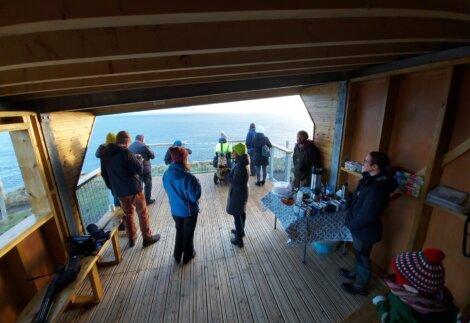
[0,18,470,71]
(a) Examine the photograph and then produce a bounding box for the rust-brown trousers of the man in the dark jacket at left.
[119,192,152,240]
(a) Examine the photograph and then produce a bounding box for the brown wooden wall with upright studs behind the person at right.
[339,66,470,306]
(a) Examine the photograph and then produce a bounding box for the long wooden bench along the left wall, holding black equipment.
[17,216,122,322]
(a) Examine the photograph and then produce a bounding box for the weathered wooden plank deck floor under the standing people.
[61,174,381,323]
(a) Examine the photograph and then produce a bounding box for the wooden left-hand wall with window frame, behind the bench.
[0,114,66,322]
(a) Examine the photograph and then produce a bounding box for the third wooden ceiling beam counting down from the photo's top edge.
[0,43,440,88]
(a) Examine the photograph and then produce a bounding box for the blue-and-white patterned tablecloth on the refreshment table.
[261,192,352,243]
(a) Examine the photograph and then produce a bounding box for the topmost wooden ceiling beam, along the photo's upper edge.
[0,0,470,36]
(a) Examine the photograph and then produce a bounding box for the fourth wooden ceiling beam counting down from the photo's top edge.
[0,56,390,96]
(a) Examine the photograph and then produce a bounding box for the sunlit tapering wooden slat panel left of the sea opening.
[50,112,95,227]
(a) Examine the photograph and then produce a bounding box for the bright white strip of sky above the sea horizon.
[125,95,308,117]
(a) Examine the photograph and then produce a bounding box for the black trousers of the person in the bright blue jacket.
[173,215,197,262]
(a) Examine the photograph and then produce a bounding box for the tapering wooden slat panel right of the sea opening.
[299,83,339,180]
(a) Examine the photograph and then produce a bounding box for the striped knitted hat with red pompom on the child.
[394,249,445,294]
